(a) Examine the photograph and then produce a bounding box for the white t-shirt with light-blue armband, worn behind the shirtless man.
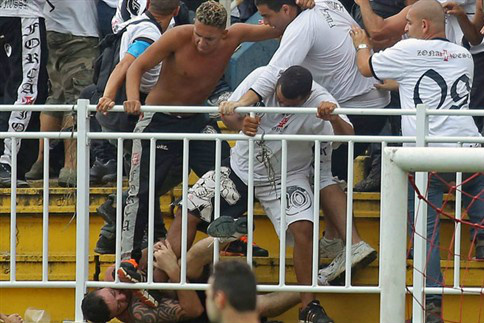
[119,13,161,93]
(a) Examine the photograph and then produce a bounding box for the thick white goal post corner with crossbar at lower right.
[380,147,484,323]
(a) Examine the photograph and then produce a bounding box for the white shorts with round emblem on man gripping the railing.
[254,174,319,240]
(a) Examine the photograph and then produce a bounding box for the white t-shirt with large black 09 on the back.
[370,39,480,146]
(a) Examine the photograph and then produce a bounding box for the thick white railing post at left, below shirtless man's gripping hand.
[75,100,89,322]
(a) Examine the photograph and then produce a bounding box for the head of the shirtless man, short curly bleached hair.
[193,0,227,54]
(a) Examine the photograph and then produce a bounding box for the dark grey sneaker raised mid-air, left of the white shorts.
[207,215,247,241]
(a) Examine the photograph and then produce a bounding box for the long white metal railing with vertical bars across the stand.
[0,100,484,322]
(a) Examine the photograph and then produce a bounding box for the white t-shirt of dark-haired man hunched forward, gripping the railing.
[229,67,349,185]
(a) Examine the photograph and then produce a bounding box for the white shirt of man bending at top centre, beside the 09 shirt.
[251,0,390,108]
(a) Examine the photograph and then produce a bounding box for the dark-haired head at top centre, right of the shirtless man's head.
[255,0,301,32]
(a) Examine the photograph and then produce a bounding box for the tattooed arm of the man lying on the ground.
[130,298,188,323]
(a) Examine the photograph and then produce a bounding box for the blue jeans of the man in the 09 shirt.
[408,173,484,302]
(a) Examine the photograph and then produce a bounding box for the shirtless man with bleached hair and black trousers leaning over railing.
[118,1,296,276]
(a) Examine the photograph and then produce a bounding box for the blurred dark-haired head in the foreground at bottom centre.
[206,260,257,323]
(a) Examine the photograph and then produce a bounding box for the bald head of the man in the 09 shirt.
[405,0,445,39]
